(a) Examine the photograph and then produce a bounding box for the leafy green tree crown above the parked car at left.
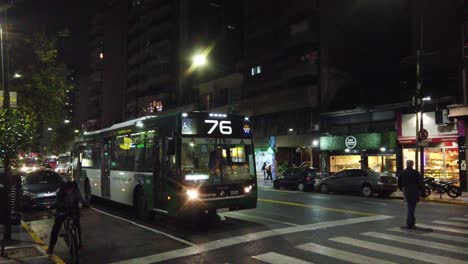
[11,31,73,152]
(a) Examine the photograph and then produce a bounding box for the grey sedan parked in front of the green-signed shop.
[315,169,398,197]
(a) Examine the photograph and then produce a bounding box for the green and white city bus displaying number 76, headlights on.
[73,112,257,218]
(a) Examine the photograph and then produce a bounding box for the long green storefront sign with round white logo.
[320,132,397,151]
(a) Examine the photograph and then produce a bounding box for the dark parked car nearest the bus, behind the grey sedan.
[273,167,320,191]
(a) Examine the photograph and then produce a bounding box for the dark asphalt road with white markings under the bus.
[24,188,468,264]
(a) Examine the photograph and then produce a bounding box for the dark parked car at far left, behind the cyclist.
[21,169,64,208]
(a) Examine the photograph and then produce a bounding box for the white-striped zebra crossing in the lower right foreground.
[252,215,468,264]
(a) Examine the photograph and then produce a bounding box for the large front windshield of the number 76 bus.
[181,138,253,184]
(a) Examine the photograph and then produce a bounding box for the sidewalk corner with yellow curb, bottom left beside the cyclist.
[0,222,57,264]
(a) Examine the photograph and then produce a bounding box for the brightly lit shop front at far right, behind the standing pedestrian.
[398,112,460,180]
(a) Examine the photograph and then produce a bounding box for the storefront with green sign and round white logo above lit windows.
[320,132,397,174]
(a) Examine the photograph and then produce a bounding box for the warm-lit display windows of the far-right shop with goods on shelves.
[403,147,459,180]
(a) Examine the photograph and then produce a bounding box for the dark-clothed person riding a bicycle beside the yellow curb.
[47,181,83,254]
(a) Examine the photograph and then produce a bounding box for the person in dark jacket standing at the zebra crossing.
[398,160,424,229]
